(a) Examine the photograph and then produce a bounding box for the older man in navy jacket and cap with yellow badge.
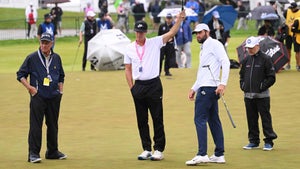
[17,33,67,163]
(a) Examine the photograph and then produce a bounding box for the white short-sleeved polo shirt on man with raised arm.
[124,36,163,80]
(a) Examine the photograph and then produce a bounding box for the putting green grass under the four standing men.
[0,37,300,169]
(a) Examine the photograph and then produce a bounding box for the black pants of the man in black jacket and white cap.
[244,97,277,146]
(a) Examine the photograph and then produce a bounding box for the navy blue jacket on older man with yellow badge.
[17,49,65,98]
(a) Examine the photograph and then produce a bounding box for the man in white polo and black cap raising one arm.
[124,11,186,161]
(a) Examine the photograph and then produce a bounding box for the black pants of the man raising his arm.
[131,77,166,152]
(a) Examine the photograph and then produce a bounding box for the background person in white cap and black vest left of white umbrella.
[79,11,98,71]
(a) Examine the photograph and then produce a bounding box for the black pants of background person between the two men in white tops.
[159,43,177,73]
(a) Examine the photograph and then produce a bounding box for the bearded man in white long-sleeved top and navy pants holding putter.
[186,23,230,165]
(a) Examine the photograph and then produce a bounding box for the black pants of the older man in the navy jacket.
[28,94,62,155]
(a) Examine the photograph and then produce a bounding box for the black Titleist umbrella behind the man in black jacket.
[236,36,289,72]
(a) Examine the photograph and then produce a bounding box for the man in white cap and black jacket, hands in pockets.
[240,36,277,151]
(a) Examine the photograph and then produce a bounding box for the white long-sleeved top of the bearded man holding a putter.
[192,37,230,91]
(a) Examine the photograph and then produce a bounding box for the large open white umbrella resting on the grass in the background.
[87,29,131,70]
